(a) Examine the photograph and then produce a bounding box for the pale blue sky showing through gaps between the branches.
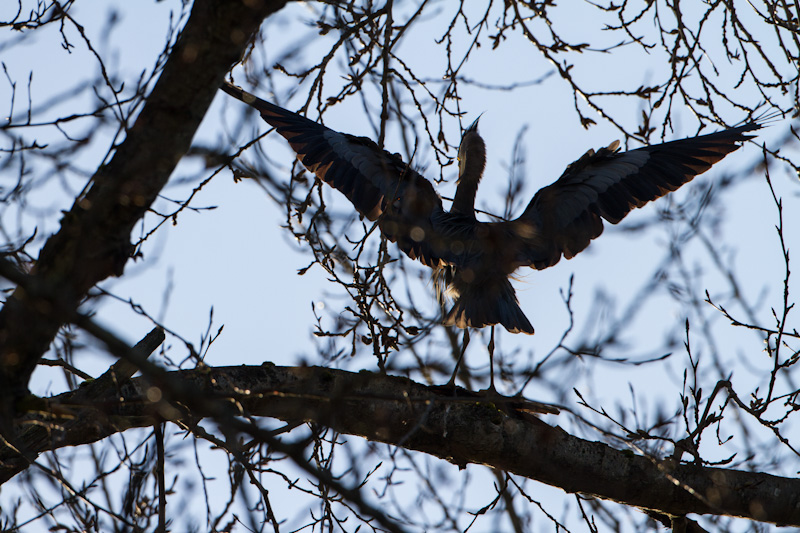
[0,0,800,528]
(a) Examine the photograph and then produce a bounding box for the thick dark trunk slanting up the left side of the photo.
[0,0,286,426]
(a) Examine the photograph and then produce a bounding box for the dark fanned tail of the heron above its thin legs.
[444,278,533,335]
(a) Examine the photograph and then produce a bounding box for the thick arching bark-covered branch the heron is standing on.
[0,365,800,526]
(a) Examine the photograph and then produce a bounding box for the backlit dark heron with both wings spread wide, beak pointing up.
[221,82,762,335]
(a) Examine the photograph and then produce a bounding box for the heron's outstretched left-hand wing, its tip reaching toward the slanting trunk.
[222,83,450,266]
